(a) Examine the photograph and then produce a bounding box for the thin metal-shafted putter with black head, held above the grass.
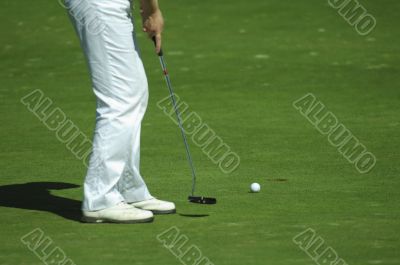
[152,37,217,204]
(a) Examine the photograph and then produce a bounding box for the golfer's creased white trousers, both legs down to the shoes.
[65,0,152,211]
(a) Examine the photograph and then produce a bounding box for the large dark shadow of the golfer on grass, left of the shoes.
[0,182,81,221]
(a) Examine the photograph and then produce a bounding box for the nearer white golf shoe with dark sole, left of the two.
[82,202,154,224]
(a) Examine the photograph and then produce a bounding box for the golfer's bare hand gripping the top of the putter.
[140,5,164,53]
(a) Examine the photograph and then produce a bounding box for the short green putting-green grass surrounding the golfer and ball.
[0,0,400,265]
